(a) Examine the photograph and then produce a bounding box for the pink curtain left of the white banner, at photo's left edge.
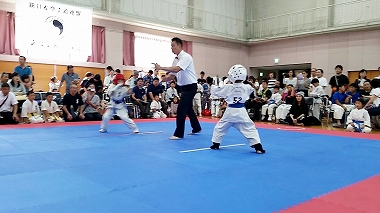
[0,11,19,55]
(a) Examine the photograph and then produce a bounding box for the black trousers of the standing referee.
[174,83,202,138]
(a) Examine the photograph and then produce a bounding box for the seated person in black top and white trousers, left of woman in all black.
[276,84,295,124]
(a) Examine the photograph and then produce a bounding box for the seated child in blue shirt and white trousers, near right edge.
[331,85,355,127]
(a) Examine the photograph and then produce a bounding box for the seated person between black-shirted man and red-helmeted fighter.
[82,84,102,121]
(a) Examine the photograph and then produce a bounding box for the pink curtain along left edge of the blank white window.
[123,31,135,66]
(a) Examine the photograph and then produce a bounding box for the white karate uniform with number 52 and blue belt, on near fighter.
[211,83,260,146]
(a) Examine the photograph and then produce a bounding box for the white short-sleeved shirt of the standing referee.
[172,50,197,86]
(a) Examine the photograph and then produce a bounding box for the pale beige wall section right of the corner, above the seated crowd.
[248,30,380,93]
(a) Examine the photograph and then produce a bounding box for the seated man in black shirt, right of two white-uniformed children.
[62,84,85,122]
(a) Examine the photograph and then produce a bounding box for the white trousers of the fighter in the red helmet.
[100,103,139,132]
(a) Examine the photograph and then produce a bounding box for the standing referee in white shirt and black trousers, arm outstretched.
[154,38,202,140]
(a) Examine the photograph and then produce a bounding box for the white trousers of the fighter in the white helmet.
[211,107,261,146]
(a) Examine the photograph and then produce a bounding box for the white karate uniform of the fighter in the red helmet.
[100,84,139,132]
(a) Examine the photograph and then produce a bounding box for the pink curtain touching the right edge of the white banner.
[87,26,106,64]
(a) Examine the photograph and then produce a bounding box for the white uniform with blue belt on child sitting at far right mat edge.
[346,109,372,133]
